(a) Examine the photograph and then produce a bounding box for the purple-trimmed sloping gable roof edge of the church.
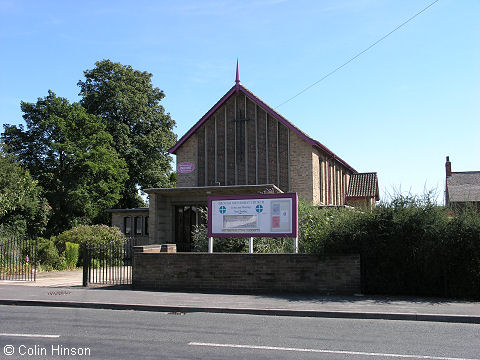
[168,81,357,173]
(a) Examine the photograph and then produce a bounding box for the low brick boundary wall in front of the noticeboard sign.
[133,253,360,294]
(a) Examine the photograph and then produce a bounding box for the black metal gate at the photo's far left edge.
[0,239,37,281]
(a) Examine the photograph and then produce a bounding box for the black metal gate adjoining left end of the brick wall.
[83,237,145,286]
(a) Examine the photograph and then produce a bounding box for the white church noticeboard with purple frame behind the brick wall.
[208,193,298,238]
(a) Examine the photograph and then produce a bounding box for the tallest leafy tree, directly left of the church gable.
[78,60,176,207]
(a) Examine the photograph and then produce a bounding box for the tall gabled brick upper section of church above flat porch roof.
[170,64,357,205]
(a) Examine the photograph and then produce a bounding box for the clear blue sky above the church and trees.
[0,0,480,201]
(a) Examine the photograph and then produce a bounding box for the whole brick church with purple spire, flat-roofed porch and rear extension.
[111,62,379,251]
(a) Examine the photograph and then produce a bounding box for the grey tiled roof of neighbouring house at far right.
[447,171,480,202]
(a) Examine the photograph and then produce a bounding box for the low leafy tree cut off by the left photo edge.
[0,148,50,237]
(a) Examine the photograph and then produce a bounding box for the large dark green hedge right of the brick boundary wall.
[317,195,480,299]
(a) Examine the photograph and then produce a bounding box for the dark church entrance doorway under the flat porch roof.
[175,205,200,252]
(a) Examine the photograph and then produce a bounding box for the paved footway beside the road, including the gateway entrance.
[0,271,480,324]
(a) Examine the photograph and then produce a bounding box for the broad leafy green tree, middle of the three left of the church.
[3,91,128,234]
